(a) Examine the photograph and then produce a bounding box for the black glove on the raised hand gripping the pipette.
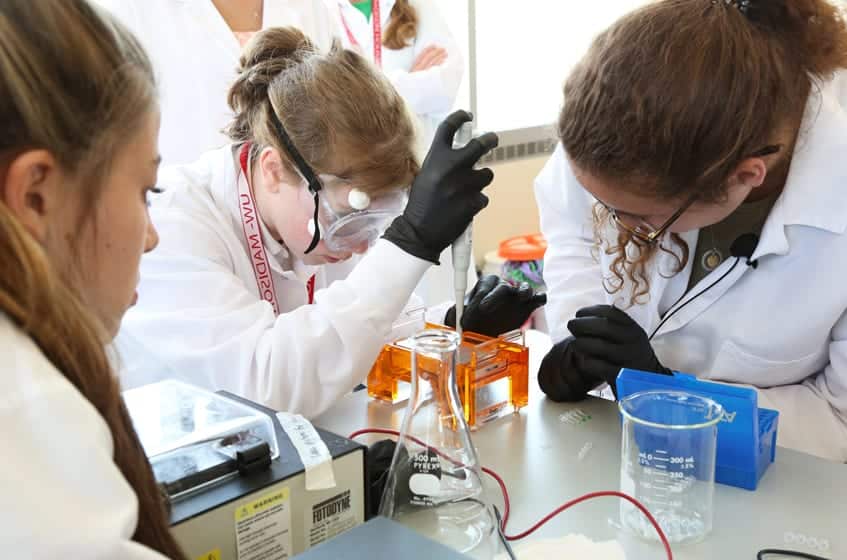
[383,111,498,264]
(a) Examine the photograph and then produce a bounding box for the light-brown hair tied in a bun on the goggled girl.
[227,27,418,193]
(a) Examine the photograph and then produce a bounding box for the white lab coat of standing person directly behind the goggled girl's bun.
[95,0,336,164]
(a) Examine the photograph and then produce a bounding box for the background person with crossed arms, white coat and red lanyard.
[324,0,470,306]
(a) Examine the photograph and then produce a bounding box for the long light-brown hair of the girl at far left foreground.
[0,0,183,558]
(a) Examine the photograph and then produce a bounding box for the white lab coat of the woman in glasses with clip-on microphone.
[535,72,847,462]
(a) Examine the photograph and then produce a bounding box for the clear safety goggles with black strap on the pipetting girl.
[270,107,407,254]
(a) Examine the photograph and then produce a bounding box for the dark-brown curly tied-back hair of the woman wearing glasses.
[558,0,847,303]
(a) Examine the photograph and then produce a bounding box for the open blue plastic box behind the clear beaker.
[617,369,779,490]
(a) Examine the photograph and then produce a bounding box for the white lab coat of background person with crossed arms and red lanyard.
[325,0,465,153]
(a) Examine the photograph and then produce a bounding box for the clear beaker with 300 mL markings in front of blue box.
[618,391,723,543]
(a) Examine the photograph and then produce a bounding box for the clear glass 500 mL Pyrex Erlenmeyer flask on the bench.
[380,329,501,560]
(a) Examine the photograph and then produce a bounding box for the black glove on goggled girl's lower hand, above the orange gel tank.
[444,274,547,336]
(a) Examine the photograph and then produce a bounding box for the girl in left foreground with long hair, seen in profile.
[0,0,184,560]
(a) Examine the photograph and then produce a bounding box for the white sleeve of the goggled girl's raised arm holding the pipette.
[124,209,429,417]
